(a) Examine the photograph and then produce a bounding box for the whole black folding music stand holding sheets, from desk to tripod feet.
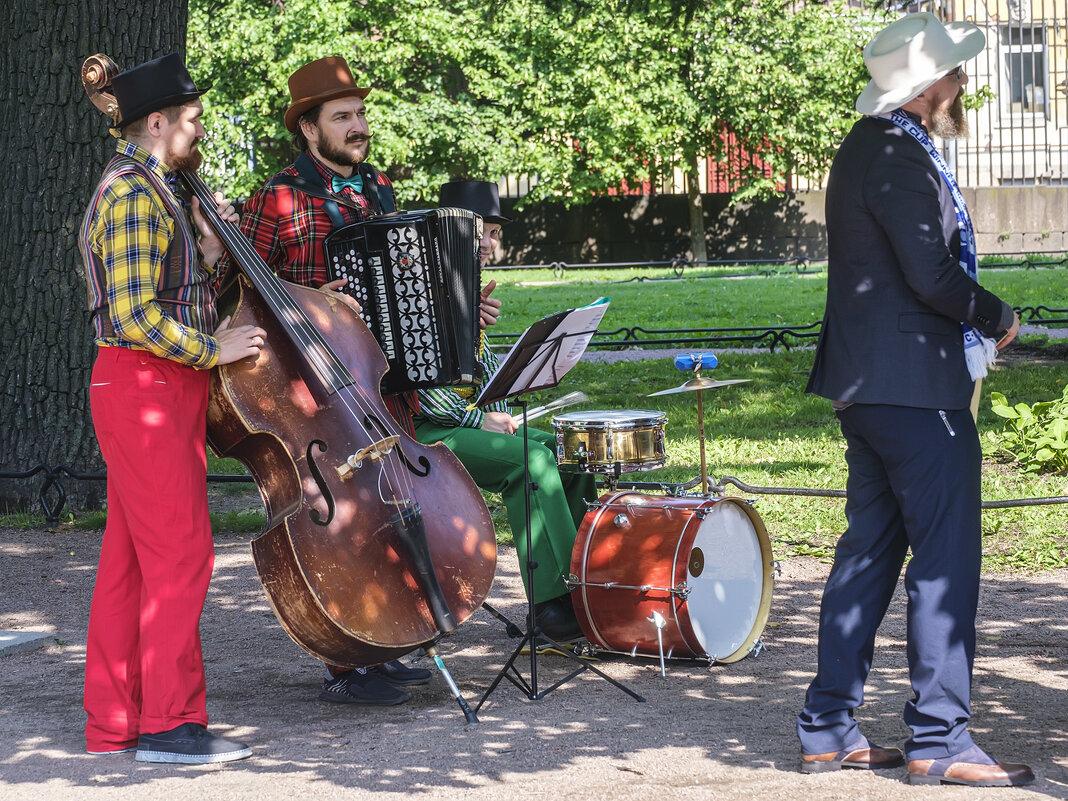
[475,298,645,712]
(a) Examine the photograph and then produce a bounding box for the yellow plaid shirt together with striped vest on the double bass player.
[78,139,219,368]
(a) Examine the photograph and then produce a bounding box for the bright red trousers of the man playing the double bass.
[84,347,215,751]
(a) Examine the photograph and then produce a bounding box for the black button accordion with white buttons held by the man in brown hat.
[325,208,484,393]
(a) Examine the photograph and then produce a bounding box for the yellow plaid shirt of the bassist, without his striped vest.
[82,139,219,368]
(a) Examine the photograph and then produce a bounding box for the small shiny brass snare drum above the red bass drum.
[552,409,668,474]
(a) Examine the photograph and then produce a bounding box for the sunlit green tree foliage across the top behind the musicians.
[188,0,884,203]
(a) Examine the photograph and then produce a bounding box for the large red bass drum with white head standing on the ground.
[568,491,774,662]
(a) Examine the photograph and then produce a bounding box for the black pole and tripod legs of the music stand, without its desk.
[474,399,645,712]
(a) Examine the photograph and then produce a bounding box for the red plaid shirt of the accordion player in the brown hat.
[233,153,419,427]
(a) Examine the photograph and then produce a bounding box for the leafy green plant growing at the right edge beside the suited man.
[985,387,1068,473]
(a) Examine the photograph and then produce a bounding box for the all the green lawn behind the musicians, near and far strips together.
[12,257,1068,570]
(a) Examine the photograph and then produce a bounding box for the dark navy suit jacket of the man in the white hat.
[806,117,1012,409]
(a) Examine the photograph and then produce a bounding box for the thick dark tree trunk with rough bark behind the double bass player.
[0,0,187,511]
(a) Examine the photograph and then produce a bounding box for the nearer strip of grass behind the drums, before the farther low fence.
[521,351,1068,569]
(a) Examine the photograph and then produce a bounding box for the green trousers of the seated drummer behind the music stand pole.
[415,418,597,603]
